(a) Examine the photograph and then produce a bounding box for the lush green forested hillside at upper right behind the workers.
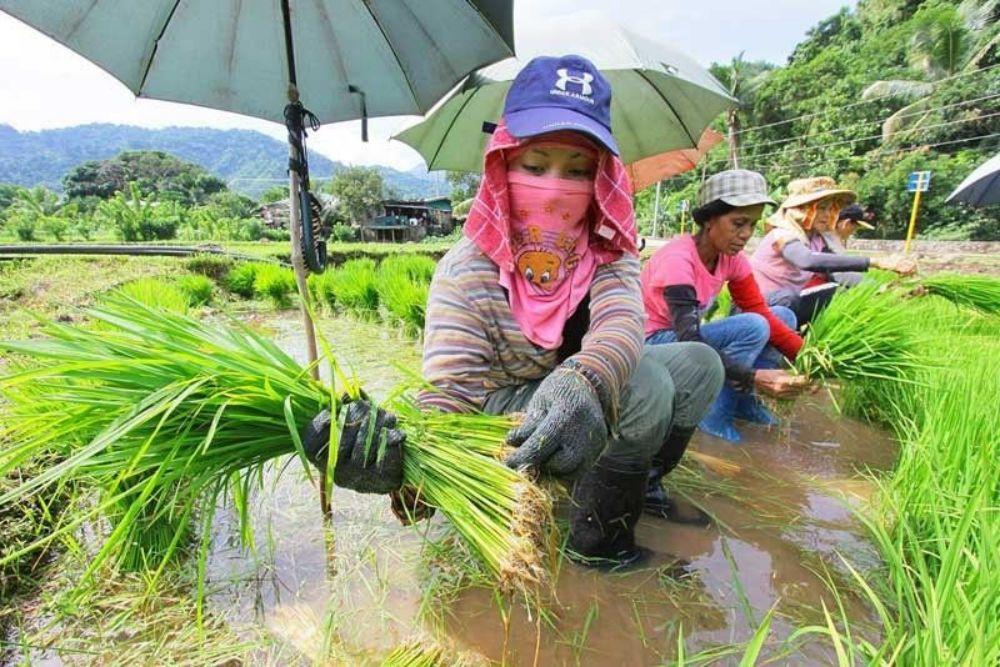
[639,0,1000,240]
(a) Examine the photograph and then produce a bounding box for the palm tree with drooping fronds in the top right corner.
[861,0,1000,141]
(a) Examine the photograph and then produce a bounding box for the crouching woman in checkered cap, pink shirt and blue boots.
[642,169,806,444]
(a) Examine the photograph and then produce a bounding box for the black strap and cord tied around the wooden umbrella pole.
[285,100,327,273]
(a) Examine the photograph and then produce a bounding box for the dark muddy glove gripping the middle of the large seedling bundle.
[302,399,406,493]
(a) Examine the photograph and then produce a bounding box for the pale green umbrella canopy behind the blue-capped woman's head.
[394,12,735,172]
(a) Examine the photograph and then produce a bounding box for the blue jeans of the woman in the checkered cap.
[646,306,796,376]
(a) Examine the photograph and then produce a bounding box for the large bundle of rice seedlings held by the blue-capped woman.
[0,296,549,588]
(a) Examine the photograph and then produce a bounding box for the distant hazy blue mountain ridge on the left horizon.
[0,124,446,196]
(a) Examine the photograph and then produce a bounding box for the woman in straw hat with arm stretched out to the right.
[750,176,916,326]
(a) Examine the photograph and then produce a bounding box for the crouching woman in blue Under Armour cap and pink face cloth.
[300,56,722,567]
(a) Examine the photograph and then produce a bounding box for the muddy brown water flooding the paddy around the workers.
[201,319,895,665]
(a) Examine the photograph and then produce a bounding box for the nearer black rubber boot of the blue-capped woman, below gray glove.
[567,460,649,570]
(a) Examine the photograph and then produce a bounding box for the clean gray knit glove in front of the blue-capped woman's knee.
[506,364,608,478]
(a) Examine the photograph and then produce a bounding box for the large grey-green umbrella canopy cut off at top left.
[0,0,513,122]
